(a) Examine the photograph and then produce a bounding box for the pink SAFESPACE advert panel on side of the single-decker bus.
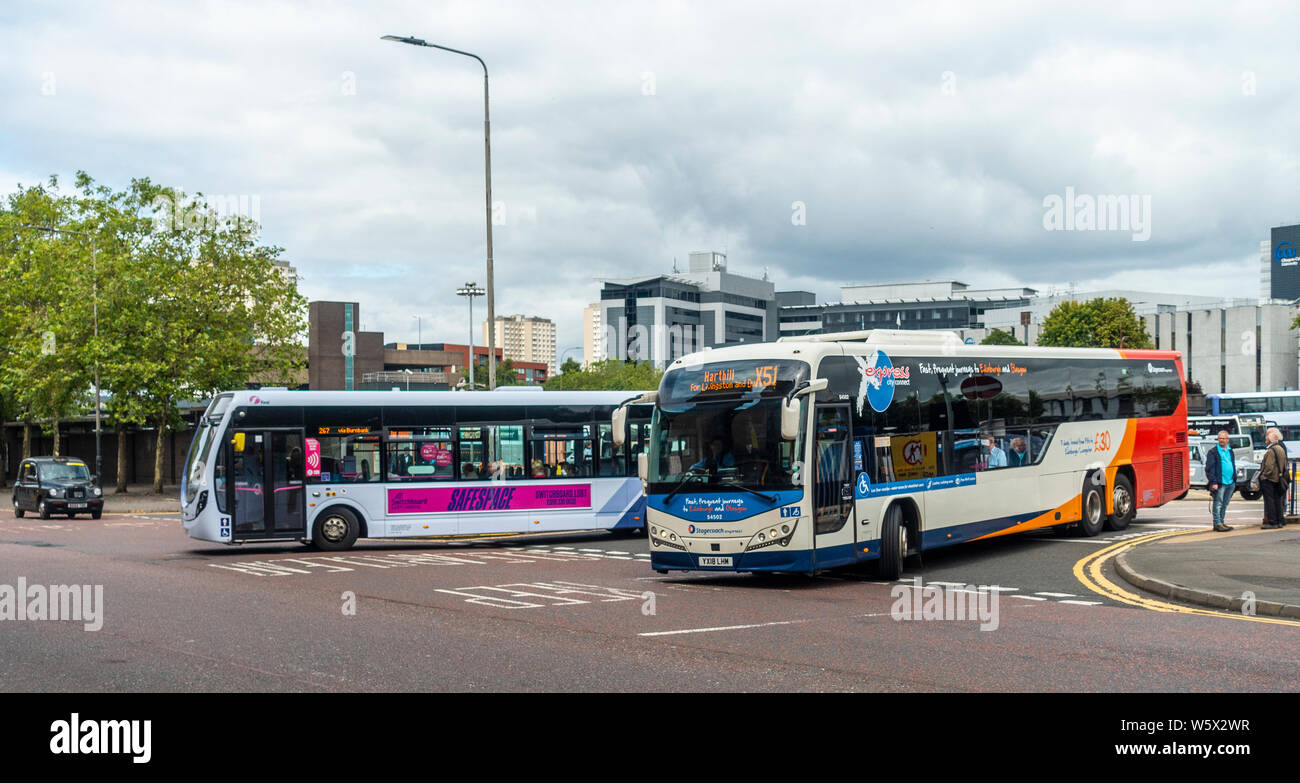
[389,484,592,514]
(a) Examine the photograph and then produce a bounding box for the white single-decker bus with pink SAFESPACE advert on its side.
[181,389,650,550]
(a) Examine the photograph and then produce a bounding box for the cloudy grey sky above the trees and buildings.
[0,1,1300,351]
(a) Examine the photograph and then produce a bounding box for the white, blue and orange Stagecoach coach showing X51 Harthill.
[614,330,1188,579]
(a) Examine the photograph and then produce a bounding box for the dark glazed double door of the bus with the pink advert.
[226,429,306,540]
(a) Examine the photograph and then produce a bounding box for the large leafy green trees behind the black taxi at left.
[0,172,307,490]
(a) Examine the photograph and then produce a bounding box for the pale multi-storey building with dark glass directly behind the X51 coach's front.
[593,252,779,367]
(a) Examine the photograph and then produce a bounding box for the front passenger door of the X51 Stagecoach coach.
[813,405,857,568]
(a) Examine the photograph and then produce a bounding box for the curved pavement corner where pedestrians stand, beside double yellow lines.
[1114,494,1300,619]
